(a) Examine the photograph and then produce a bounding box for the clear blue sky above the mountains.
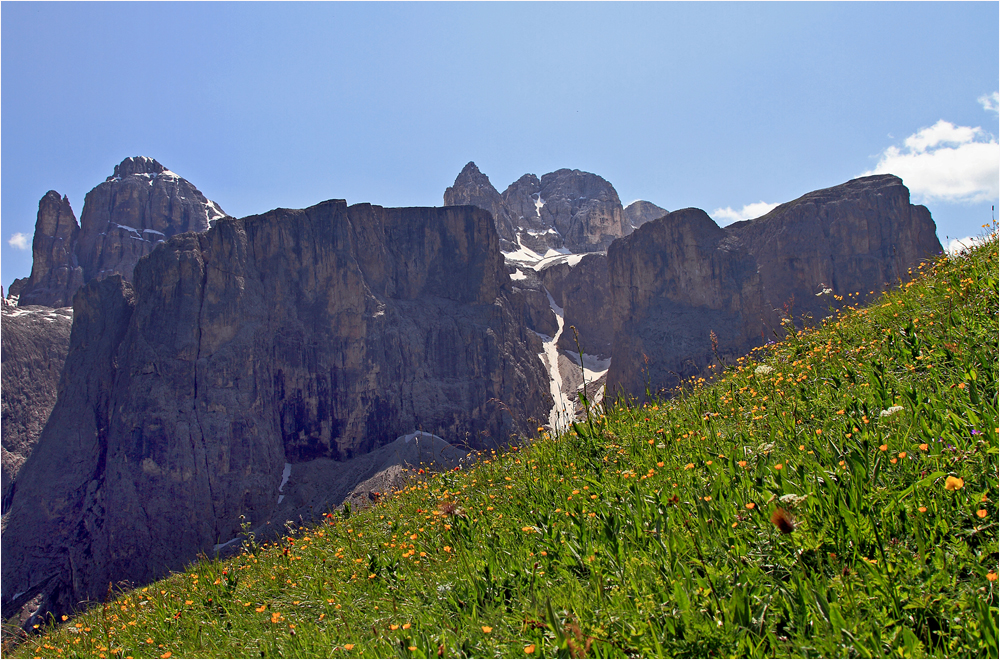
[0,2,1000,289]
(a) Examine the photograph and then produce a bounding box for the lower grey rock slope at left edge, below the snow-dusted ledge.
[0,299,73,514]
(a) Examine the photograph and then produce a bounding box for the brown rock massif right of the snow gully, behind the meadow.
[607,175,941,398]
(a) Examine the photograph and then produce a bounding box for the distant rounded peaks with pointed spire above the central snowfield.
[444,162,666,255]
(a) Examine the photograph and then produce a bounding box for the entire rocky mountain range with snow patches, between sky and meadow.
[2,157,941,625]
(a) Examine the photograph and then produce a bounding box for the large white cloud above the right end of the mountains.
[861,119,1000,202]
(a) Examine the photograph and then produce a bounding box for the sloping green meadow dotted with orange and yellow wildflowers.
[8,227,1000,658]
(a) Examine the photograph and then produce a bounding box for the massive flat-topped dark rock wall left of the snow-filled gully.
[2,200,552,617]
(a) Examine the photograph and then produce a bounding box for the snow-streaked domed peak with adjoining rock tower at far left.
[11,156,225,307]
